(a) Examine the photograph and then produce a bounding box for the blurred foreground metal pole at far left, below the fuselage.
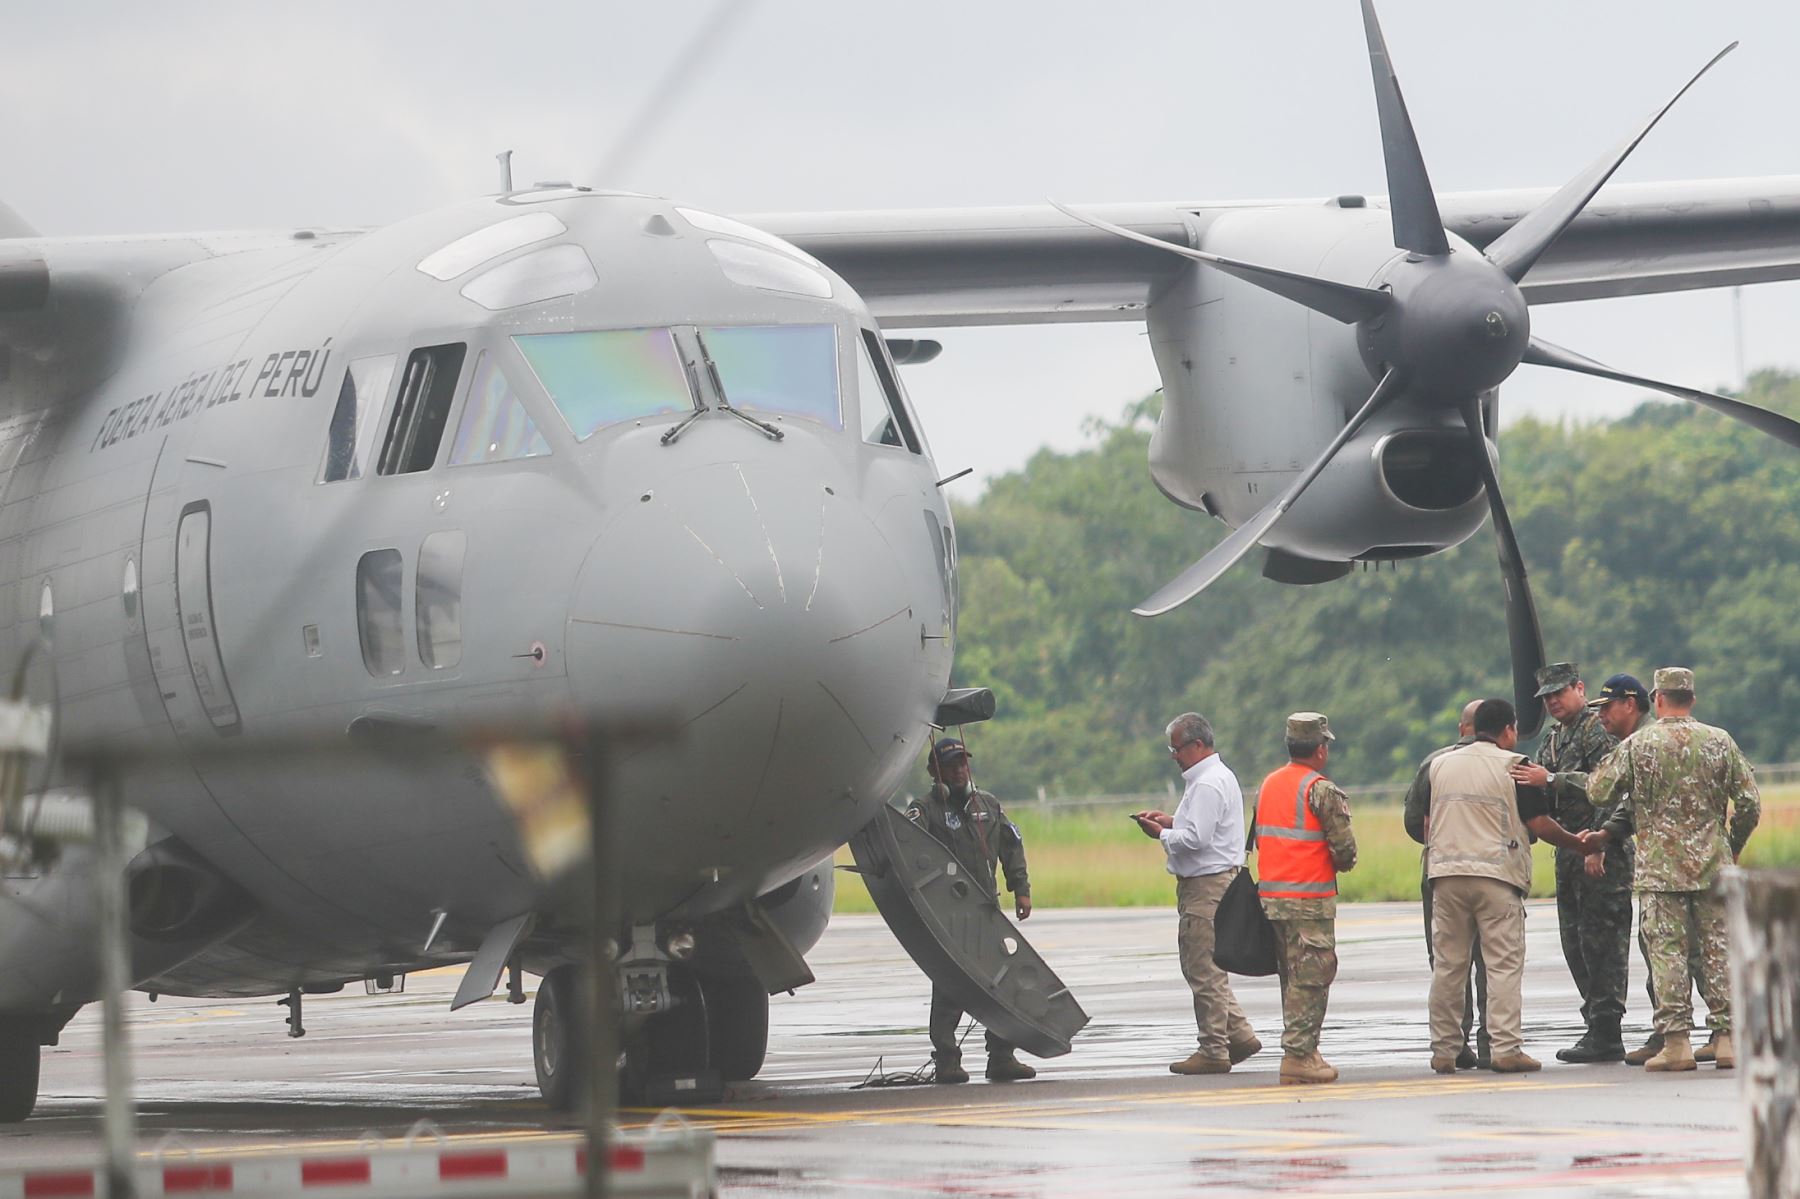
[94,765,137,1199]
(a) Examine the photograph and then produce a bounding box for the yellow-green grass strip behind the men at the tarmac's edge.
[837,785,1800,913]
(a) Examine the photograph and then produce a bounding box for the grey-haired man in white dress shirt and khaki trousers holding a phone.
[1132,711,1262,1075]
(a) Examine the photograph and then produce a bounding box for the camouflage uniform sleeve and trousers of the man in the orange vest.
[1262,778,1355,1057]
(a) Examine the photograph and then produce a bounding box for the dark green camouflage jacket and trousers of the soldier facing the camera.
[1534,709,1631,1028]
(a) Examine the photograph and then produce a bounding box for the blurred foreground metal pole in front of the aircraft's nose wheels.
[583,733,619,1199]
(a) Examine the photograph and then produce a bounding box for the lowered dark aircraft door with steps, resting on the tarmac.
[850,805,1087,1057]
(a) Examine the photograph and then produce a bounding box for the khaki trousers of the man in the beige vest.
[1431,875,1525,1057]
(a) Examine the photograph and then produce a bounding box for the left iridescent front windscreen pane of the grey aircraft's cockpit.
[513,329,693,441]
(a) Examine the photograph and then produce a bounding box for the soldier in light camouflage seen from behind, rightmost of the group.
[1582,666,1762,1071]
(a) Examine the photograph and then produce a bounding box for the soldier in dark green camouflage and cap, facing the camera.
[1512,663,1631,1062]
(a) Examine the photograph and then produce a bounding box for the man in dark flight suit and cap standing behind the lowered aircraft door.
[907,736,1037,1082]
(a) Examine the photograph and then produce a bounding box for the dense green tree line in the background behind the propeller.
[918,363,1800,799]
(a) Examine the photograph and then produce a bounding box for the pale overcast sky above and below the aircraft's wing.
[0,0,1800,495]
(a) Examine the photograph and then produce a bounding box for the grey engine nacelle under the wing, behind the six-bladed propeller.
[1148,202,1496,568]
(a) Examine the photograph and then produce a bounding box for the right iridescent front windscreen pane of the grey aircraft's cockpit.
[700,324,844,428]
